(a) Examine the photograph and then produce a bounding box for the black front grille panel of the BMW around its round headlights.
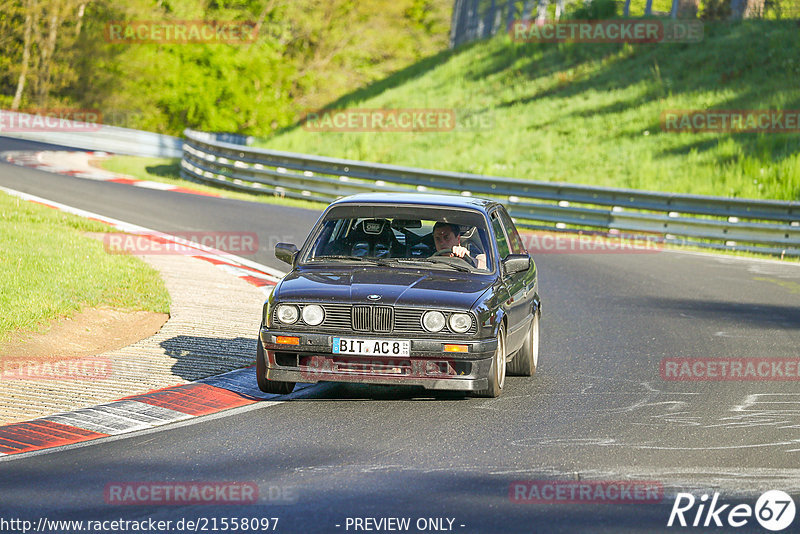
[273,303,478,337]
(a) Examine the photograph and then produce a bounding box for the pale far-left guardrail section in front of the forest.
[0,110,183,158]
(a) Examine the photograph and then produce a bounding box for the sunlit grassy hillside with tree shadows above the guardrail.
[260,21,800,200]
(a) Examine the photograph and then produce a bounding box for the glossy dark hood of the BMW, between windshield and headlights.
[275,266,492,309]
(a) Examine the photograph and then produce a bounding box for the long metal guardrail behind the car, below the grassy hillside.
[181,130,800,256]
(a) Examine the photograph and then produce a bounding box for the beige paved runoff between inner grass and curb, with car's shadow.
[0,254,265,425]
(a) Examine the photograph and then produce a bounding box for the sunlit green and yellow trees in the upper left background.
[0,0,452,135]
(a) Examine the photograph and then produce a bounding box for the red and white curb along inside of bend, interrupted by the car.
[0,187,294,457]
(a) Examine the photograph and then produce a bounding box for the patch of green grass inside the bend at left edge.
[0,193,170,340]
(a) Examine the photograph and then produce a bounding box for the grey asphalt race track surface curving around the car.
[0,138,800,533]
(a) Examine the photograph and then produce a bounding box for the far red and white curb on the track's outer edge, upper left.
[0,150,220,197]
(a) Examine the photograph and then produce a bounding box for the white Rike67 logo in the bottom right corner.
[667,490,796,532]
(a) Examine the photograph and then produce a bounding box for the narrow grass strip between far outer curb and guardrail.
[100,156,327,210]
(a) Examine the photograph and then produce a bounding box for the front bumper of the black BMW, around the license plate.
[259,328,497,391]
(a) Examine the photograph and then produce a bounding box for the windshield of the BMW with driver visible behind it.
[301,206,493,272]
